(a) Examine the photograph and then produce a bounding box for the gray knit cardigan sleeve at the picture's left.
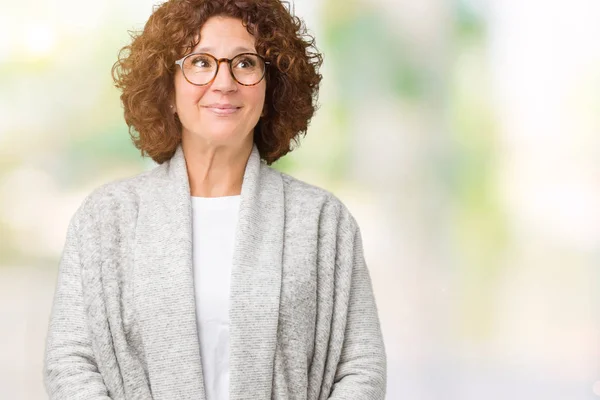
[43,208,110,400]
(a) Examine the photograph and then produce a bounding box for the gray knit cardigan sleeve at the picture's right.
[329,223,387,400]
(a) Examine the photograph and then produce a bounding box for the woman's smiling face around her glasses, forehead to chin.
[174,16,266,145]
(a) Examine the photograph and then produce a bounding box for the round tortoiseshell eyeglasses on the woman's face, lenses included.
[175,53,270,86]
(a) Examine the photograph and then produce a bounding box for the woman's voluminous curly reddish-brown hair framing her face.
[111,0,323,165]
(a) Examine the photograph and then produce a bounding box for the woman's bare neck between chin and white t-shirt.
[182,135,253,197]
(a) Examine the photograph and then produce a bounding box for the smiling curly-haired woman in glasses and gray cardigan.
[44,0,386,400]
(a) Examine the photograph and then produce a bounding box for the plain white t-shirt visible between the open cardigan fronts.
[191,195,240,400]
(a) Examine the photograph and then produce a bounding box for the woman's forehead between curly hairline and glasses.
[194,16,255,56]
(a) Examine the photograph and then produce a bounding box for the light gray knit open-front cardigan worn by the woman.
[43,145,386,400]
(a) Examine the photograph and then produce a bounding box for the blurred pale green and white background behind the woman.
[0,0,600,400]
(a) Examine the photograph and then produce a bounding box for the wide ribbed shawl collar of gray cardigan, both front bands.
[135,144,284,400]
